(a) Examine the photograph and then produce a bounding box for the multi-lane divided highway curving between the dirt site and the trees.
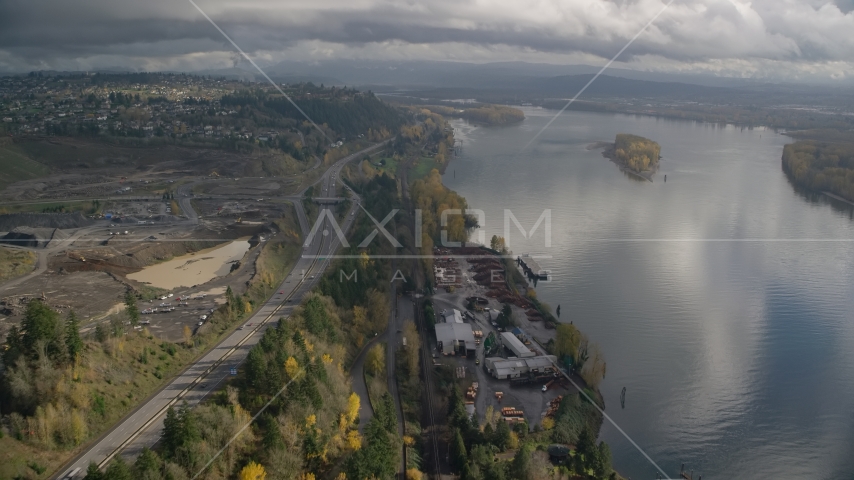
[59,142,386,479]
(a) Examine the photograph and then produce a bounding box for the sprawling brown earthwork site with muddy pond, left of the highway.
[0,139,314,341]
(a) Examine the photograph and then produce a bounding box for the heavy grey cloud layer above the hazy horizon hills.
[0,0,854,77]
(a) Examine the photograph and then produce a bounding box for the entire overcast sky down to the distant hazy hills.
[0,0,854,84]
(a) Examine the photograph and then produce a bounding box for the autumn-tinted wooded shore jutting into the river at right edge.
[783,140,854,201]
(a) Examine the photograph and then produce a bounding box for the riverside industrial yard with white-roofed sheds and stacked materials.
[433,247,574,427]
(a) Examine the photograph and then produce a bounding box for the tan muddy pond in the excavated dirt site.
[128,240,249,290]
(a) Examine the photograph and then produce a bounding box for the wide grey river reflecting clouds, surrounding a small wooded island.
[444,108,854,480]
